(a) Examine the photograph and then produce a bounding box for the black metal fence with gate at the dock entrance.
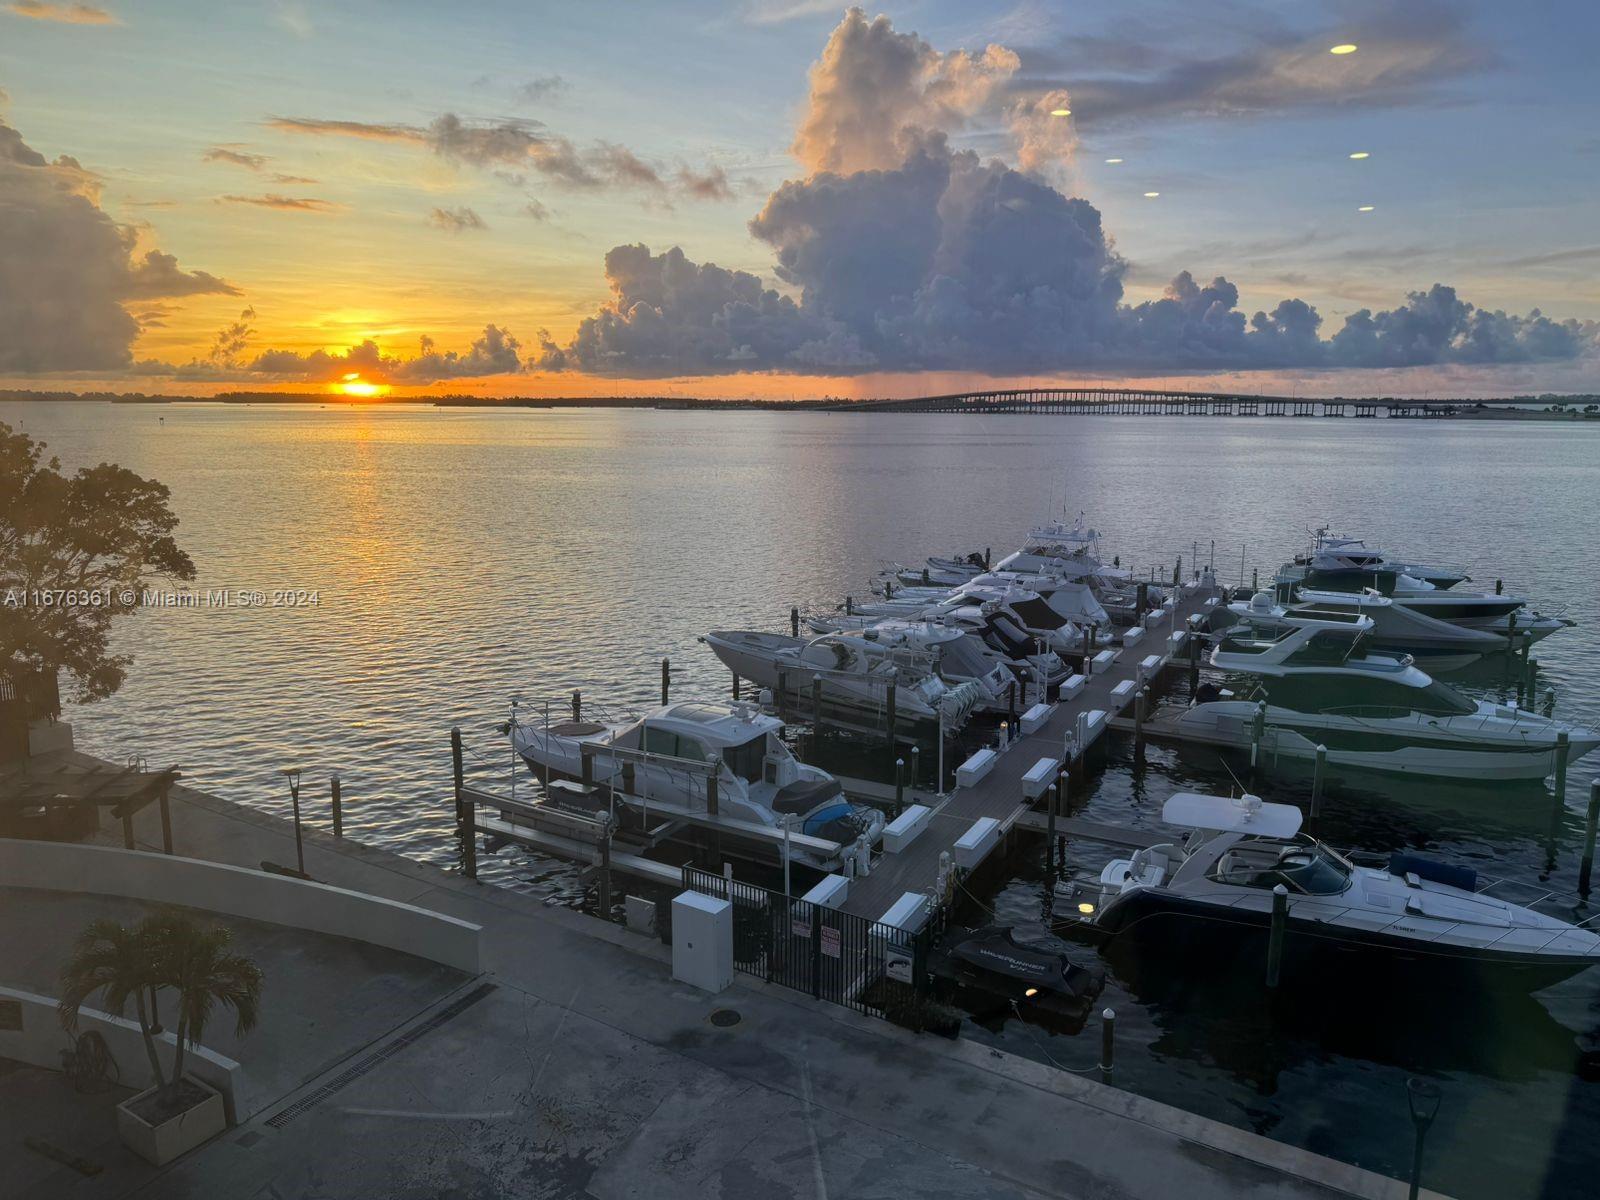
[683,866,931,1014]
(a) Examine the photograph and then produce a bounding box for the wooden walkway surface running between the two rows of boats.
[842,592,1214,920]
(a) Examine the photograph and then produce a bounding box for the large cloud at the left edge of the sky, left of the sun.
[0,122,237,373]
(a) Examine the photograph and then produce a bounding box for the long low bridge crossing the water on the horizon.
[837,387,1550,418]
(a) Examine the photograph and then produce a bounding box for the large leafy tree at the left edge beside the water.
[0,422,195,701]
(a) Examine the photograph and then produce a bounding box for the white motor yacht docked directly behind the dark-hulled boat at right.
[1176,592,1600,779]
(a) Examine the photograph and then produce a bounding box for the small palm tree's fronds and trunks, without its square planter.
[58,912,261,1099]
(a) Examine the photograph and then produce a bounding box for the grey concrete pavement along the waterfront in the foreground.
[3,752,1452,1200]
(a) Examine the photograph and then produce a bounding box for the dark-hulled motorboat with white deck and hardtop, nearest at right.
[1091,792,1600,990]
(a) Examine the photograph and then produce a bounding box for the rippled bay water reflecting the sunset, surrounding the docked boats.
[12,403,1600,1197]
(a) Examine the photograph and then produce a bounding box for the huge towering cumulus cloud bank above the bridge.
[538,10,1597,376]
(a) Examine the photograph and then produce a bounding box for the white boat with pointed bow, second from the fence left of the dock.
[701,629,984,730]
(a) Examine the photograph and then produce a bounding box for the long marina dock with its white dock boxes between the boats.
[842,589,1216,925]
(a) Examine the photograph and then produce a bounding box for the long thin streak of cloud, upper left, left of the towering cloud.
[267,112,726,200]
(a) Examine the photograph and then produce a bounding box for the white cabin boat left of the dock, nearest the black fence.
[509,701,883,870]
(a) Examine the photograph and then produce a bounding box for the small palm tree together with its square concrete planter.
[59,912,261,1165]
